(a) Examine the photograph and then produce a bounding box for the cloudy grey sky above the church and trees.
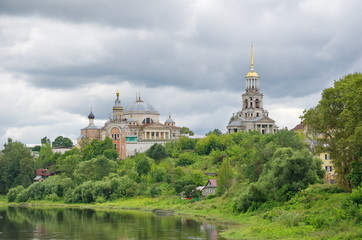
[0,0,362,145]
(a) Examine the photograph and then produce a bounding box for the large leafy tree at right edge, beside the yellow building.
[302,73,362,190]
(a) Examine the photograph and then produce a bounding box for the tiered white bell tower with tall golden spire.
[226,46,278,134]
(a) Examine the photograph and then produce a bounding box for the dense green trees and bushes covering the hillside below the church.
[0,130,324,212]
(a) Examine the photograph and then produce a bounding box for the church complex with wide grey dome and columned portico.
[78,91,181,159]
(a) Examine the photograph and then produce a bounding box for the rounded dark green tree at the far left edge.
[0,138,35,194]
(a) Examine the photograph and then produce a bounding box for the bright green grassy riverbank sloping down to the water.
[0,185,362,239]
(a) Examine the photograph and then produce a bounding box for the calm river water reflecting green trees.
[0,207,223,240]
